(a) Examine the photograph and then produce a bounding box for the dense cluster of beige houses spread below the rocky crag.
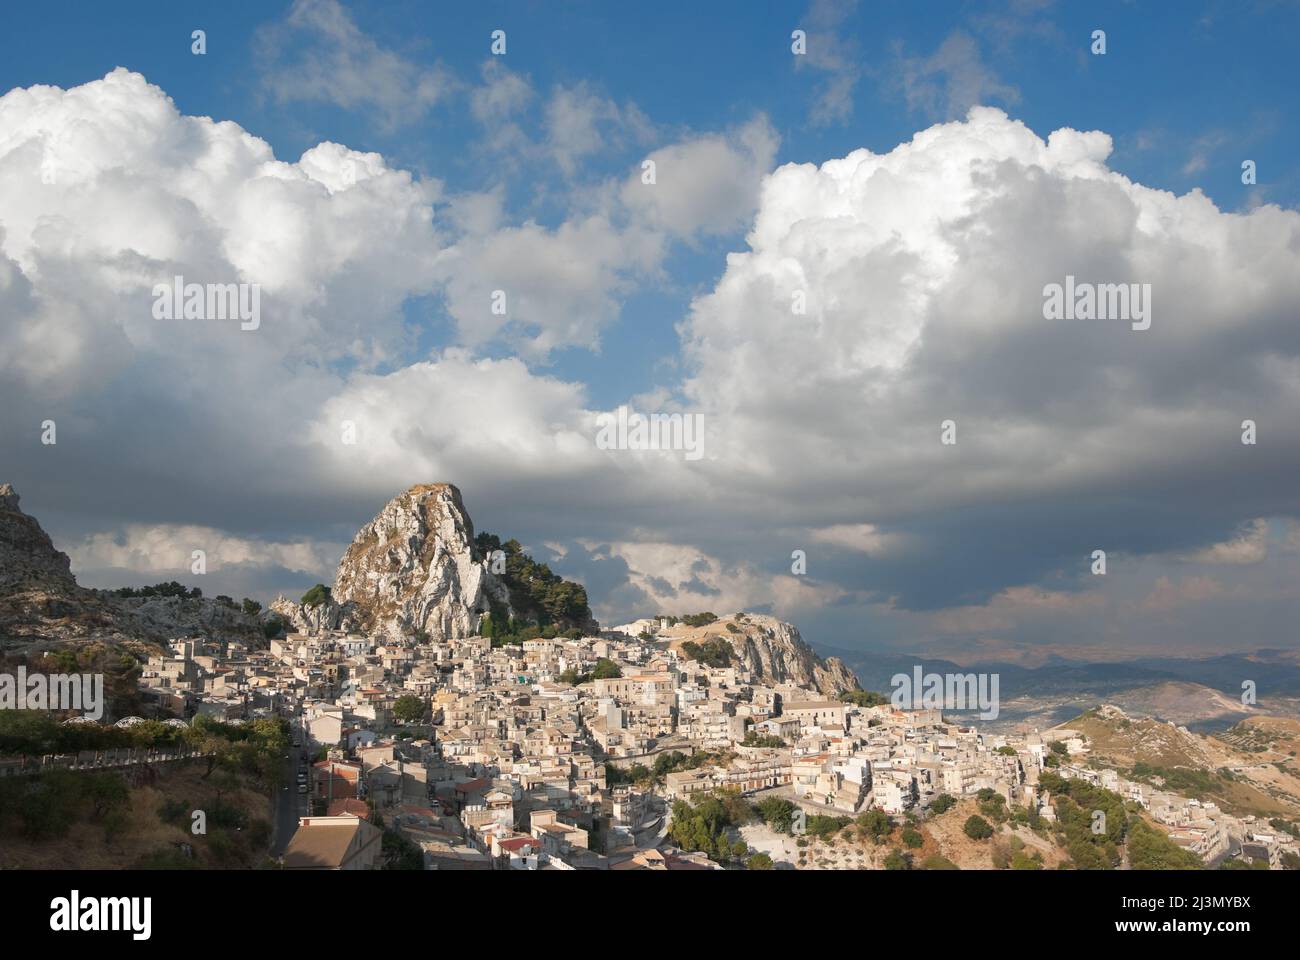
[140,620,1290,870]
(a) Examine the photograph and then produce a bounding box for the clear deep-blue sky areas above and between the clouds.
[0,1,1300,403]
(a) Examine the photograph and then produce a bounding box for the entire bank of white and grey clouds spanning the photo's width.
[0,70,1300,645]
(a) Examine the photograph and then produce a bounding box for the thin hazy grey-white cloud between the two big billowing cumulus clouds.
[436,115,779,359]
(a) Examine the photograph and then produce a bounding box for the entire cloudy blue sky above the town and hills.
[0,0,1300,660]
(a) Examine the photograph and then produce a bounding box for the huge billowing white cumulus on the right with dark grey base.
[683,108,1300,606]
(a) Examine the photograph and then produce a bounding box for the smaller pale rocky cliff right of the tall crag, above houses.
[662,613,858,697]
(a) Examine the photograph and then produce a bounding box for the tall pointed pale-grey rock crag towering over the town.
[272,484,514,640]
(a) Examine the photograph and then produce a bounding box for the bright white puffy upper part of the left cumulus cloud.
[0,69,439,392]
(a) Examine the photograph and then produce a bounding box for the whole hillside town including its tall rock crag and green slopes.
[0,484,1300,870]
